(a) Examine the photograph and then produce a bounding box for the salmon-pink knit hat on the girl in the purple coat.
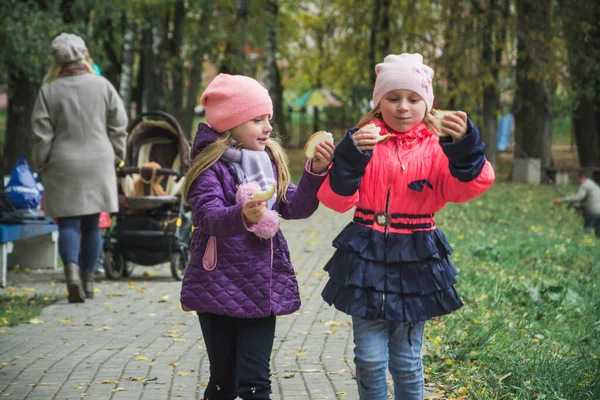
[200,74,273,133]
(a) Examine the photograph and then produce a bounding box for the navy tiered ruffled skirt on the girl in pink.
[322,223,463,323]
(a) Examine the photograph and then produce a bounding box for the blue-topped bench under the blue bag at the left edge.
[0,219,58,287]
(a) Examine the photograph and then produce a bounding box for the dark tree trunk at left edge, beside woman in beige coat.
[2,70,39,175]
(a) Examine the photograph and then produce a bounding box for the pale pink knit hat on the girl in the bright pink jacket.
[373,53,433,111]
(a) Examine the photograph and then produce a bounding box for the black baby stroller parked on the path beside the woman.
[103,111,192,281]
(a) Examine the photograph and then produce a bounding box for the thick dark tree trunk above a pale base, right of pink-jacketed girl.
[515,0,553,181]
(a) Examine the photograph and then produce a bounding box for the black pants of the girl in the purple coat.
[198,313,275,400]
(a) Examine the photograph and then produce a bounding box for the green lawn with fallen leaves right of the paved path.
[425,182,600,400]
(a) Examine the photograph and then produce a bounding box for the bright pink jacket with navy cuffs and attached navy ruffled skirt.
[318,119,494,323]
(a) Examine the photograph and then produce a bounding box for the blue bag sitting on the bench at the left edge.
[4,158,42,212]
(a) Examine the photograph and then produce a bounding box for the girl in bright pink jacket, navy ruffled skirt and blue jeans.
[318,54,494,400]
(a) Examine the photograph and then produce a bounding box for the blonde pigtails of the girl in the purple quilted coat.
[183,131,291,203]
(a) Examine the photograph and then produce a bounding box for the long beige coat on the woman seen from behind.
[31,74,127,217]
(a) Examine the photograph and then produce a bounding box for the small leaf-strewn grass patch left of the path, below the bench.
[0,288,58,327]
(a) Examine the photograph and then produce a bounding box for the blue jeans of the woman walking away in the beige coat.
[58,214,102,272]
